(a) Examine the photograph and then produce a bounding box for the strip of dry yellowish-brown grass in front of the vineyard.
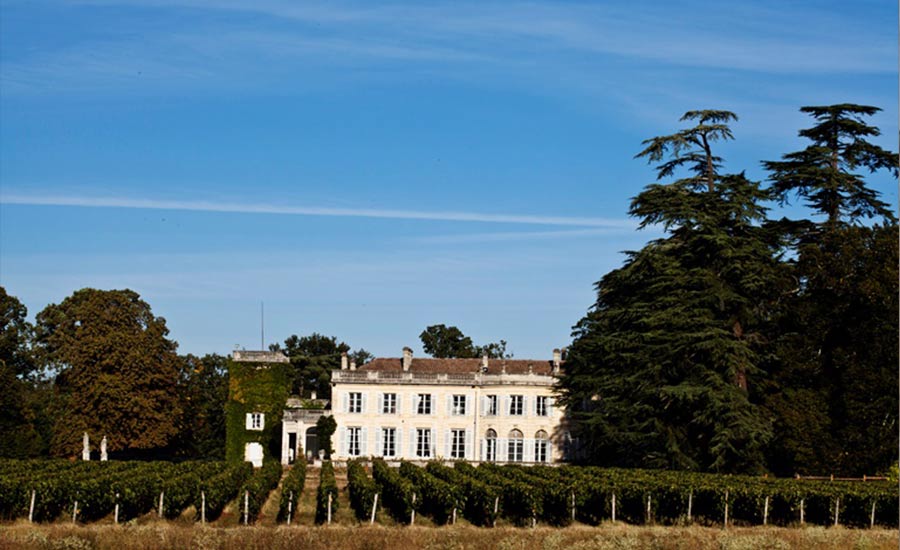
[0,523,900,550]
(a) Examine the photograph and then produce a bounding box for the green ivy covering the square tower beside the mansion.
[225,361,291,462]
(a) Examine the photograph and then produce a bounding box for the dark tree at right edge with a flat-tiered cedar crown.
[763,104,898,475]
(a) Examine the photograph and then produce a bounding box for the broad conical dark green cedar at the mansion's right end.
[560,111,777,472]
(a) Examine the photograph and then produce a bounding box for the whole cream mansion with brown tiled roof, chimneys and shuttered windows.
[331,348,569,463]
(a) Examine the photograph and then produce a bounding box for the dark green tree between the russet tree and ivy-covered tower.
[173,354,230,460]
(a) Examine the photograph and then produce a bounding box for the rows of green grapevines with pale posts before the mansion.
[0,459,898,528]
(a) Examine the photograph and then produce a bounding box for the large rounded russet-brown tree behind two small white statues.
[36,288,181,456]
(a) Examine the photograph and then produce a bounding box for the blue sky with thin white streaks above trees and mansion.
[0,0,898,358]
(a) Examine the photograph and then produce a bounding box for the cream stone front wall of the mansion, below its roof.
[331,371,564,463]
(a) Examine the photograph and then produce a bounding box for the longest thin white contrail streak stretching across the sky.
[0,194,636,229]
